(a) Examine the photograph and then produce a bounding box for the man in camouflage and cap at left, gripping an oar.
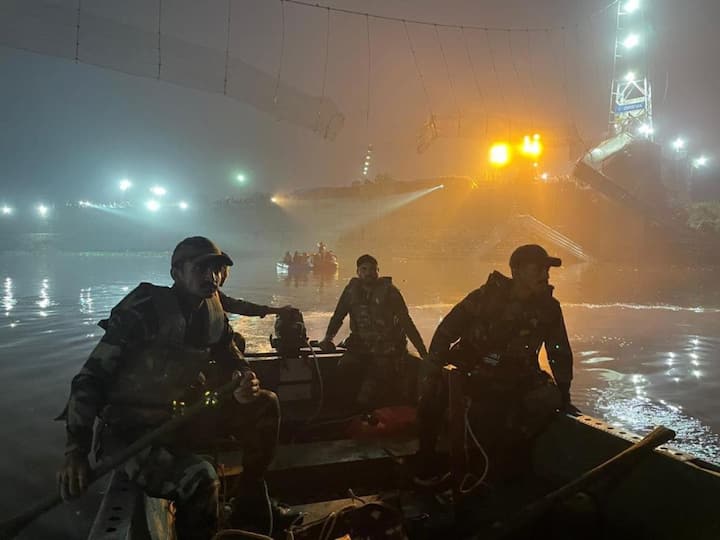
[58,237,280,540]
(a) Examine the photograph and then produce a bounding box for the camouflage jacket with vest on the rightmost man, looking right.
[430,272,573,384]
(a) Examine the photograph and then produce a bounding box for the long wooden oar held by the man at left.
[0,377,243,540]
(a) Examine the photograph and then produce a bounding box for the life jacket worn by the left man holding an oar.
[100,284,226,429]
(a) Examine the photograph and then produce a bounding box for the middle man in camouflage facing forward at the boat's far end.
[320,255,427,411]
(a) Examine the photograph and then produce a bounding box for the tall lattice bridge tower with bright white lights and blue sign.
[609,0,654,140]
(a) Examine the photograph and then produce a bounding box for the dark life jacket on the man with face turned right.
[454,272,560,380]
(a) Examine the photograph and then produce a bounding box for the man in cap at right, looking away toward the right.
[416,244,572,483]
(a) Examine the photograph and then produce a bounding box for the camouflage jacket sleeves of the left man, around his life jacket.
[60,283,250,453]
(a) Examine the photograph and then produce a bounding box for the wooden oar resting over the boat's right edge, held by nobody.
[481,426,675,540]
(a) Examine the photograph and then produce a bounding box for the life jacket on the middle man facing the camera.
[348,277,407,354]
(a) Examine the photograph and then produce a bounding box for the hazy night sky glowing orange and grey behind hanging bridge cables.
[0,0,720,205]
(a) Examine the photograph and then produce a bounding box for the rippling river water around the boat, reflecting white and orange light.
[0,253,720,539]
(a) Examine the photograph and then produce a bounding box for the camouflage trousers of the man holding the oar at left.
[108,390,280,540]
